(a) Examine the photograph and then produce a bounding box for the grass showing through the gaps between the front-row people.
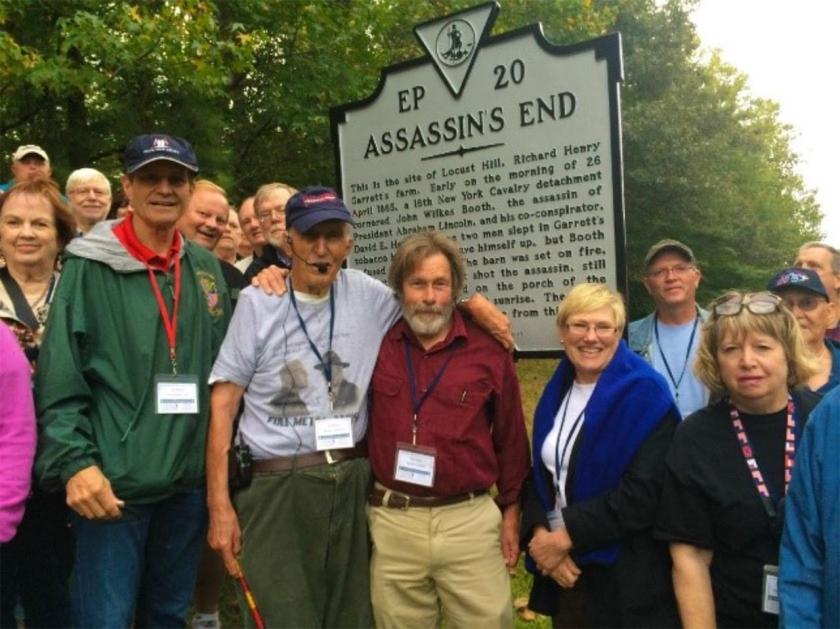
[219,359,557,629]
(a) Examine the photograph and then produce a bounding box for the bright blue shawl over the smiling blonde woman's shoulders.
[532,340,680,565]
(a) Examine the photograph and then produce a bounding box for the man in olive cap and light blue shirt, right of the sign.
[628,239,709,417]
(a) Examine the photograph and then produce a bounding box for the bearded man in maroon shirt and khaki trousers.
[368,232,528,628]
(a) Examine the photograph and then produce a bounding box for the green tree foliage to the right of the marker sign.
[616,0,821,318]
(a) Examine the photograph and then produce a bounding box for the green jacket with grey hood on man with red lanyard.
[35,221,230,502]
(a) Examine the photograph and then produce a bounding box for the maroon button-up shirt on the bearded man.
[368,311,529,507]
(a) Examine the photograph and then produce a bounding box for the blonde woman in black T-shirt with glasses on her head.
[656,291,819,627]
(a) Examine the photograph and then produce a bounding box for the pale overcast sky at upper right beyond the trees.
[694,0,840,246]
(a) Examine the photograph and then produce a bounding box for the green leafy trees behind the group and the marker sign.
[0,0,820,315]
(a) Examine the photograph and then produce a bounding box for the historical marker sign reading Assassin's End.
[331,3,626,355]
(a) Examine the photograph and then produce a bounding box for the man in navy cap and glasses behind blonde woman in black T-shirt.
[767,268,840,394]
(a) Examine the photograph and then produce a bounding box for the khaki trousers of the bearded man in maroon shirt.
[368,495,513,629]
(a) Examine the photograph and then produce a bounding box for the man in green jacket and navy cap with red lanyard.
[35,134,230,628]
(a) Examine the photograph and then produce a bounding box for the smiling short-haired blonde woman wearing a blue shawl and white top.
[522,284,679,627]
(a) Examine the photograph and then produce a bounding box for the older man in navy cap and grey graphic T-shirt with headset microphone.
[207,194,512,627]
